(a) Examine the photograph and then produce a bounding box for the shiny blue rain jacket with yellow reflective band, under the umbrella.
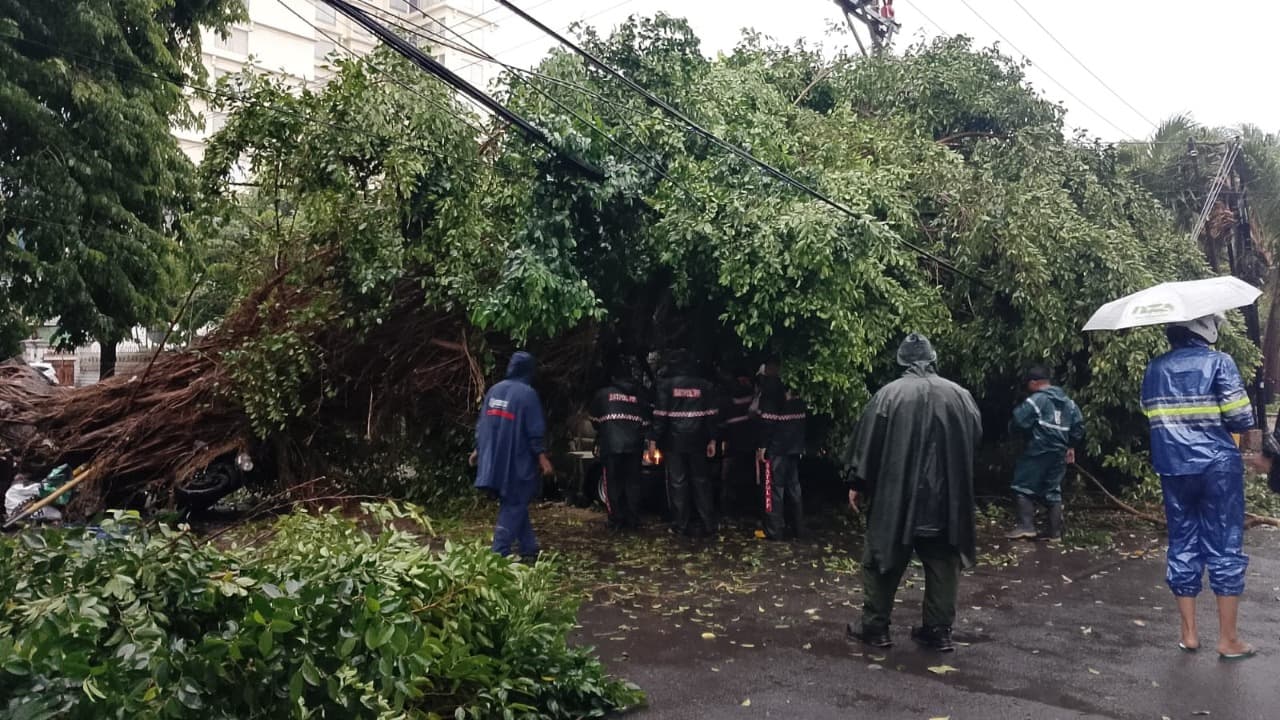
[1142,337,1253,475]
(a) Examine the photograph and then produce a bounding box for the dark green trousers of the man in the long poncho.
[863,538,960,628]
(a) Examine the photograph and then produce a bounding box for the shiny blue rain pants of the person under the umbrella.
[1161,455,1249,597]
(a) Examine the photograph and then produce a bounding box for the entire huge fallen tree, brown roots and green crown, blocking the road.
[7,26,1256,511]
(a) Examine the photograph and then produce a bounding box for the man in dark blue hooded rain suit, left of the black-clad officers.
[471,351,552,560]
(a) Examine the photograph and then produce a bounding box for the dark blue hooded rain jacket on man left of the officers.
[476,352,547,503]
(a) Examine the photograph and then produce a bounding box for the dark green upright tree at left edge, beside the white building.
[0,0,243,354]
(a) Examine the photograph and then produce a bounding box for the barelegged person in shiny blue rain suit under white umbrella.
[1142,315,1254,660]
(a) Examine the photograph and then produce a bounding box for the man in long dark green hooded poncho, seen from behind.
[845,333,982,652]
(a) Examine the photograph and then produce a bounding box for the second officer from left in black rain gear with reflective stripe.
[649,351,719,537]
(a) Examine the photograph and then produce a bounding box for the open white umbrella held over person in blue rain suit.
[1084,275,1262,331]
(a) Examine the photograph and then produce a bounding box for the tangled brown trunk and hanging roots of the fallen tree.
[0,260,485,516]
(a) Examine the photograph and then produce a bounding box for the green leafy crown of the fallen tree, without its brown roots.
[186,15,1256,474]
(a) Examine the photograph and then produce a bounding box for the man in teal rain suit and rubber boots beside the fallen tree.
[1007,366,1084,539]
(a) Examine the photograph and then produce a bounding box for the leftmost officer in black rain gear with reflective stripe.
[590,359,653,530]
